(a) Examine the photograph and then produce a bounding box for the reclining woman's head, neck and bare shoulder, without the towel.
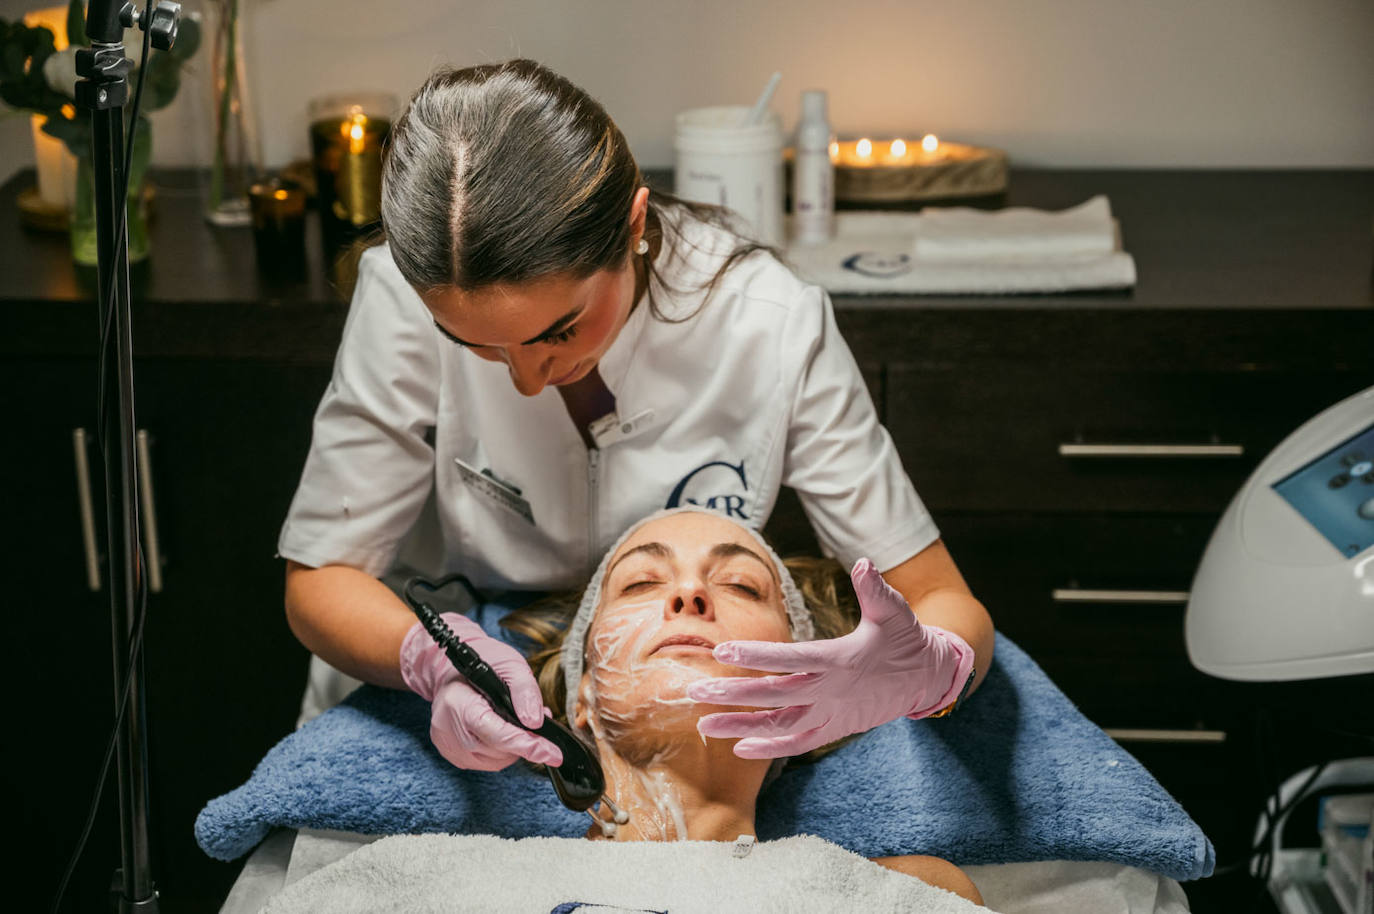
[507,509,981,903]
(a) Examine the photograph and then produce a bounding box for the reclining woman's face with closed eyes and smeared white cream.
[577,511,791,760]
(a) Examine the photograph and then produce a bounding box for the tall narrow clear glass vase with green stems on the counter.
[205,0,261,225]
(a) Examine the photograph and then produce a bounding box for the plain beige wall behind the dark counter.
[0,0,1374,188]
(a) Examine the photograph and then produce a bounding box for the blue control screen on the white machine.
[1274,425,1374,558]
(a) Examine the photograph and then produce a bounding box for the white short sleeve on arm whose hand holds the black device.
[278,247,440,576]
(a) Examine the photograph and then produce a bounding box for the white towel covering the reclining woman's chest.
[262,834,985,914]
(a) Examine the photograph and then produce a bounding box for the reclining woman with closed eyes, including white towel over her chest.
[265,509,982,913]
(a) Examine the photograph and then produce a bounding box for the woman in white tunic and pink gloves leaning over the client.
[279,60,993,770]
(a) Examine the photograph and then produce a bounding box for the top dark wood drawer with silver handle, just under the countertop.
[885,364,1370,513]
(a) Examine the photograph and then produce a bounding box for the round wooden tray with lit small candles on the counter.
[783,133,1007,202]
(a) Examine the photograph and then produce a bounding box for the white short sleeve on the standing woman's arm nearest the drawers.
[779,285,940,572]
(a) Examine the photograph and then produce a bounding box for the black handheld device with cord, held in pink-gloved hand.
[404,575,606,812]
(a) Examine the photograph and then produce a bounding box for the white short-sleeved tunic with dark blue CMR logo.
[279,211,938,599]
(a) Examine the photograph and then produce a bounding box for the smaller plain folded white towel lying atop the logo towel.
[911,194,1117,261]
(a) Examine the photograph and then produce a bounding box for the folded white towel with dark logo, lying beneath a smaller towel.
[783,204,1135,296]
